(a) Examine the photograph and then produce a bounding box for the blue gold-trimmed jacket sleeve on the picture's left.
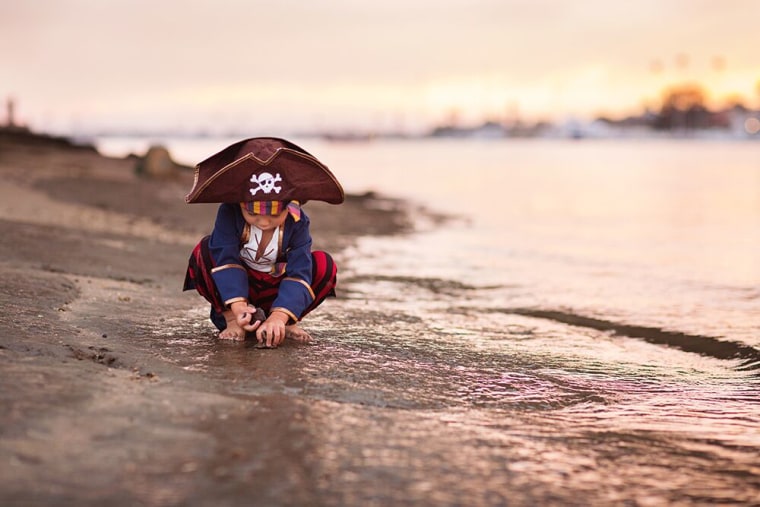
[208,204,248,306]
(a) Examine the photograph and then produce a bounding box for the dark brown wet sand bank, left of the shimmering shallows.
[0,134,411,506]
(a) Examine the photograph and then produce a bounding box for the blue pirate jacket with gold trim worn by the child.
[208,203,314,321]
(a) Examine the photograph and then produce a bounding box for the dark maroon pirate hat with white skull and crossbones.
[185,137,344,204]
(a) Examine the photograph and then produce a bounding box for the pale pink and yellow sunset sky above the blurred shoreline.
[0,0,760,133]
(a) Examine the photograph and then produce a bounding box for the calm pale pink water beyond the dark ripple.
[314,141,760,345]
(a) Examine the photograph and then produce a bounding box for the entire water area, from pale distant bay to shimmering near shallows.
[98,140,760,505]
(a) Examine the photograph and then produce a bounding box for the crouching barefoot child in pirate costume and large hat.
[184,138,344,347]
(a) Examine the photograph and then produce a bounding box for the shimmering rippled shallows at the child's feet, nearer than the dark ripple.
[156,286,760,505]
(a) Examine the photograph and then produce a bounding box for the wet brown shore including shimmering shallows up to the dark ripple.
[5,132,760,506]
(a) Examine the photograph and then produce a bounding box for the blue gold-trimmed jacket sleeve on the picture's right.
[272,213,314,323]
